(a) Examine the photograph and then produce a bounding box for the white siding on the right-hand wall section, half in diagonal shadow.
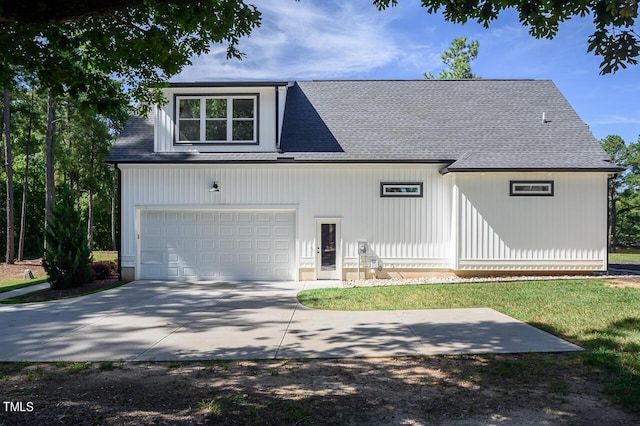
[454,172,607,270]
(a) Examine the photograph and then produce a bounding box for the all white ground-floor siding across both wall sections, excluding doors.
[120,164,607,271]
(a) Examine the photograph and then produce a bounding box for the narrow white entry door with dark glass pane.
[316,219,342,280]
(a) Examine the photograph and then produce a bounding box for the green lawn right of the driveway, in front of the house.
[298,279,640,410]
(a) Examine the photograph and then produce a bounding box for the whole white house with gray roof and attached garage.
[108,80,620,281]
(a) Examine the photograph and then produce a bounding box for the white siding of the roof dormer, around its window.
[155,87,286,152]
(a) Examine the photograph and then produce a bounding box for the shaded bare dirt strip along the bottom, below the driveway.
[0,354,640,425]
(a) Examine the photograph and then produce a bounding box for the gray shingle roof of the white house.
[108,80,617,171]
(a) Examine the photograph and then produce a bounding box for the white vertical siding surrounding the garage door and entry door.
[119,164,454,276]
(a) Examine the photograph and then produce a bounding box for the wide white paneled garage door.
[140,210,295,281]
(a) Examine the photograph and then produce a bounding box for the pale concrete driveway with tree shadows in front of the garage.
[0,281,581,361]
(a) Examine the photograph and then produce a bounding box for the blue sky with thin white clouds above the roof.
[173,0,640,143]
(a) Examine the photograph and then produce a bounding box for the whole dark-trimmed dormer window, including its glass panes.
[176,95,258,144]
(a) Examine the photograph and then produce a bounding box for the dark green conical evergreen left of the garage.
[42,184,92,289]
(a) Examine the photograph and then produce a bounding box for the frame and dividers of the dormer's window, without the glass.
[174,93,260,145]
